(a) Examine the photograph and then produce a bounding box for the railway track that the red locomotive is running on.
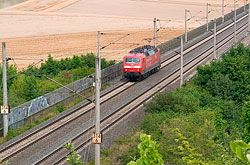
[0,35,184,161]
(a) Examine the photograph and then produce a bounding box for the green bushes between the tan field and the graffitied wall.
[0,53,115,108]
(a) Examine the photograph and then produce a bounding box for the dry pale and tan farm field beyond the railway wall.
[0,0,243,70]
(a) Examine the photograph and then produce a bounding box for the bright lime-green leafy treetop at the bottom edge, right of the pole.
[128,134,164,165]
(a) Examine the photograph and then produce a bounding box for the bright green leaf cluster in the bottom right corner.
[230,140,250,164]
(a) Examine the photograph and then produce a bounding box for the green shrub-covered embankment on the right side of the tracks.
[94,45,250,165]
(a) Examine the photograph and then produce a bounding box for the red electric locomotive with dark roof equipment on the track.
[123,45,161,80]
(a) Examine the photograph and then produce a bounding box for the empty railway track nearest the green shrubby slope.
[35,10,247,164]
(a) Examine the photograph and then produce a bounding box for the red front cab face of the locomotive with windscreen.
[123,56,142,80]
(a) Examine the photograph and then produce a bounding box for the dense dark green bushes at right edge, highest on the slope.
[195,44,250,104]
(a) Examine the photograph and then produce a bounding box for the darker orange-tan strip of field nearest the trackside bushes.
[0,29,184,70]
